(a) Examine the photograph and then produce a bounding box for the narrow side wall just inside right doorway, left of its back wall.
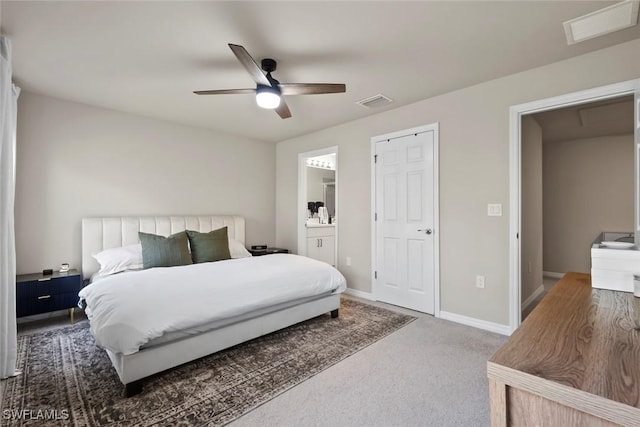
[520,116,543,301]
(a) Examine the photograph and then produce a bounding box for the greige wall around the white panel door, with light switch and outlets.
[276,40,640,325]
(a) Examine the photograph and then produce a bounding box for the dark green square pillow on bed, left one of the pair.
[138,231,192,268]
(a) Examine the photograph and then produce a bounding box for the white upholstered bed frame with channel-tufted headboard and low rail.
[82,215,340,397]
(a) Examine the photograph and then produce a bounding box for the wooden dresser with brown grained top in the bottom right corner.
[487,273,640,427]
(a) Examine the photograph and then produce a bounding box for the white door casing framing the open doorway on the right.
[509,79,640,332]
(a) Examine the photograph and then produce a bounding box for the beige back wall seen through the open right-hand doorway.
[543,135,634,273]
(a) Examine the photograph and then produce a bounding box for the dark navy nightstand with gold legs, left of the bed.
[16,270,82,323]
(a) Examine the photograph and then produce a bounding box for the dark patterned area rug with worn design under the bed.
[0,298,415,426]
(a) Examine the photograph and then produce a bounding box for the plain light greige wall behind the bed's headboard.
[15,92,275,273]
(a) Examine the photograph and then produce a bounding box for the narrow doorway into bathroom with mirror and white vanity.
[297,146,340,267]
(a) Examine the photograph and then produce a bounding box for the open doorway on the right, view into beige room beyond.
[520,95,634,320]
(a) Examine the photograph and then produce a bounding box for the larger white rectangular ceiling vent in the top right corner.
[563,0,638,45]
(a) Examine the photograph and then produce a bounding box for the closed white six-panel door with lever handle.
[374,131,437,314]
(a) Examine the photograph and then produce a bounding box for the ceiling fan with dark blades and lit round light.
[193,43,347,119]
